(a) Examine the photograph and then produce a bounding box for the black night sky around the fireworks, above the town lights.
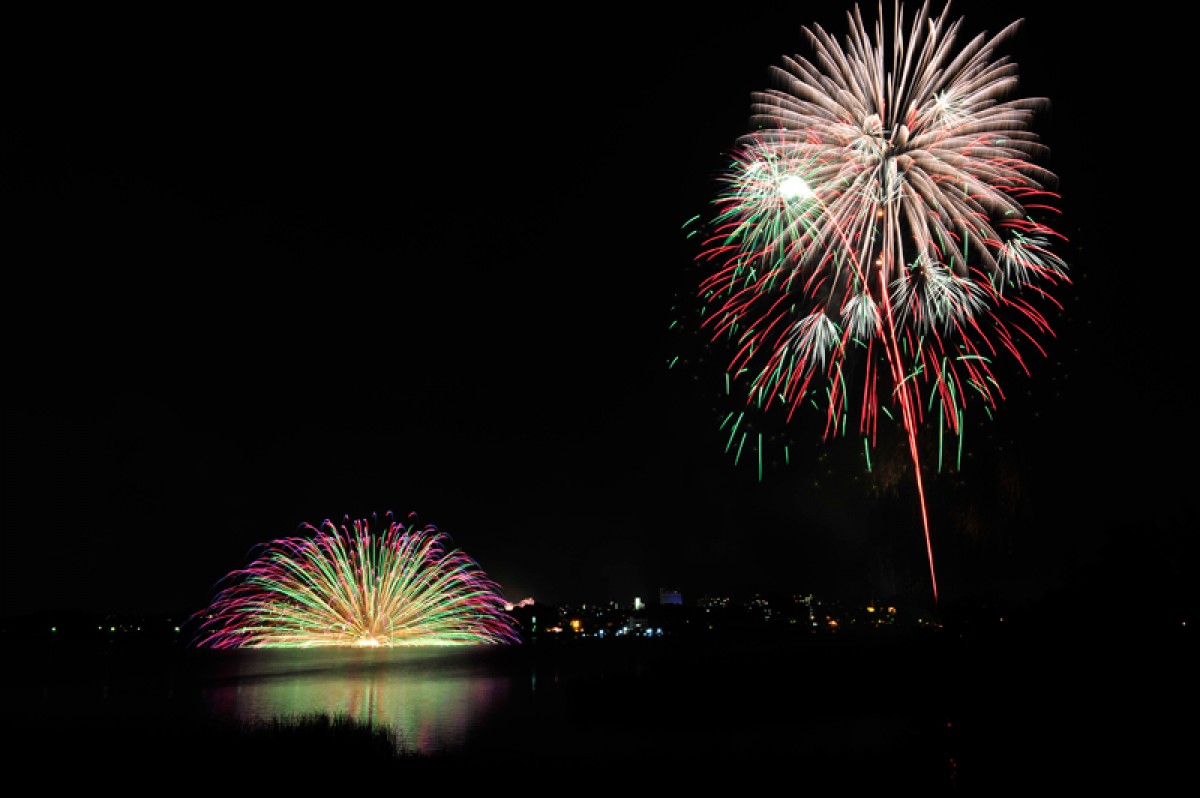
[0,2,1196,614]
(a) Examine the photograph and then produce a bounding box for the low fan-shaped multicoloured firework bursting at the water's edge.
[197,514,520,648]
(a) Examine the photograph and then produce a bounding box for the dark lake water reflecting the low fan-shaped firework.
[2,631,1195,794]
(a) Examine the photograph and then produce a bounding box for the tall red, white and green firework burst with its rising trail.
[698,2,1069,602]
